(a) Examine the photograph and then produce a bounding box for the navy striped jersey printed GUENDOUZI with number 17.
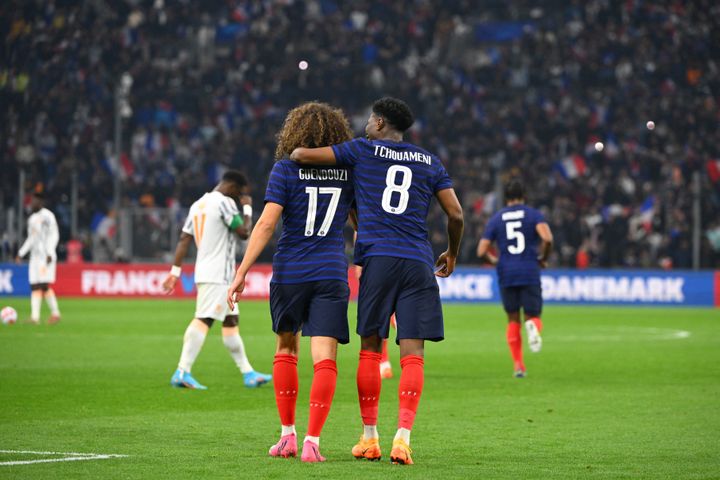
[265,160,353,283]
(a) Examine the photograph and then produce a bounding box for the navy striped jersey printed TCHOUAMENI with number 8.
[332,138,452,267]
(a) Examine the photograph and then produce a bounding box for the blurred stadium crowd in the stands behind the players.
[0,0,720,268]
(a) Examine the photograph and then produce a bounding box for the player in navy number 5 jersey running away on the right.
[477,179,553,378]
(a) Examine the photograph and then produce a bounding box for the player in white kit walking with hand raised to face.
[163,170,272,390]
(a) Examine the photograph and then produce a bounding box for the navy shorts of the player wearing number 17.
[270,280,350,344]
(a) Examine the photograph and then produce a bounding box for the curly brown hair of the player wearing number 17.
[275,102,353,160]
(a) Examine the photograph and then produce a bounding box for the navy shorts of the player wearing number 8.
[357,256,445,343]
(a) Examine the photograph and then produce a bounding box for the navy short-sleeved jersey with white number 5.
[482,205,545,287]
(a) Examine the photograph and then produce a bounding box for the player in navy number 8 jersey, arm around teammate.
[290,97,463,464]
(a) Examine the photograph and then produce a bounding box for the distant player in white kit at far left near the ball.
[15,192,60,325]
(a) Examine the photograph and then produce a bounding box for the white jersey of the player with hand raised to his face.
[182,191,240,284]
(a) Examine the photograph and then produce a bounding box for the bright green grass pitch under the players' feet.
[0,298,720,480]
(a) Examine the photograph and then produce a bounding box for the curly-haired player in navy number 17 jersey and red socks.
[228,103,353,462]
